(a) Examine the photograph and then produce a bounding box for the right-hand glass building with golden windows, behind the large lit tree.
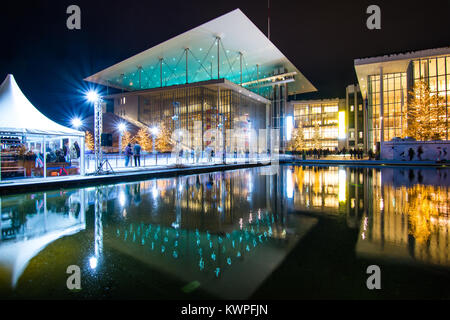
[355,47,450,150]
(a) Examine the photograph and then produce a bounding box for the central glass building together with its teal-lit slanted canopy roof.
[85,9,316,151]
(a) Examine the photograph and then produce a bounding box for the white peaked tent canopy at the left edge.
[0,74,84,136]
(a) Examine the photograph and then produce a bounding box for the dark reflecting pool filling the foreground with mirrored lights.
[0,165,450,299]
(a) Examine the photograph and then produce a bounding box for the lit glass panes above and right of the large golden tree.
[413,56,450,140]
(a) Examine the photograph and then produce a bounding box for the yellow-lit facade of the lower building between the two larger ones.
[294,100,339,150]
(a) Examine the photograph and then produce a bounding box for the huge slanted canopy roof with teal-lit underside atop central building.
[85,9,317,94]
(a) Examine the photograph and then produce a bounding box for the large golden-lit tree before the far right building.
[406,80,447,141]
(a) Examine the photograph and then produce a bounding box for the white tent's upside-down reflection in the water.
[0,190,86,288]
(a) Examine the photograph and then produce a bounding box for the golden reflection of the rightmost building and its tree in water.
[357,169,450,266]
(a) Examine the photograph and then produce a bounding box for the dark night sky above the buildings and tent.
[0,0,450,124]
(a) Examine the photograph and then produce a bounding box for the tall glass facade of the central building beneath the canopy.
[138,86,266,152]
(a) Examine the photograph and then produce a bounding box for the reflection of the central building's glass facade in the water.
[96,170,283,233]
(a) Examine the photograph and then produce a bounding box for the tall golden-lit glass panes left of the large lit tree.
[368,72,408,149]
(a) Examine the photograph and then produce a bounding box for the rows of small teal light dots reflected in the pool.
[116,210,274,276]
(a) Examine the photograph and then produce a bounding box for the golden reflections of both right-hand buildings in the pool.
[286,166,450,266]
